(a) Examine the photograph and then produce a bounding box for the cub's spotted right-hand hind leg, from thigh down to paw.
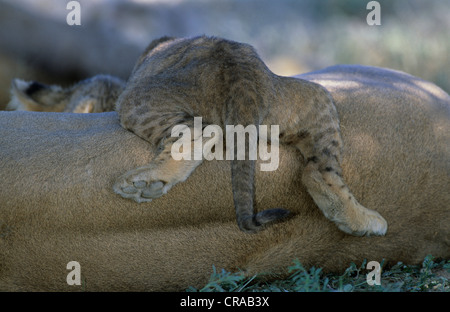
[280,81,387,236]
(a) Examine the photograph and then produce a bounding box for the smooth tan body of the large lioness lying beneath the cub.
[0,66,450,291]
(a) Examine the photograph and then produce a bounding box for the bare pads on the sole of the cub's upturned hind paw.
[113,179,167,203]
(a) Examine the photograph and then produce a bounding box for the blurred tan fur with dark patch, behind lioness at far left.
[6,75,125,113]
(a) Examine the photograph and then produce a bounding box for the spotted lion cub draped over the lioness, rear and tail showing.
[114,36,387,235]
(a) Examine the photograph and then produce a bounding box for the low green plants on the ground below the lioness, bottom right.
[187,255,450,292]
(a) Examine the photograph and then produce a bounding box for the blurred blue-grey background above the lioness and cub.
[0,0,450,109]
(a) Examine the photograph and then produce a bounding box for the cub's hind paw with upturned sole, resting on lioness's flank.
[113,169,171,203]
